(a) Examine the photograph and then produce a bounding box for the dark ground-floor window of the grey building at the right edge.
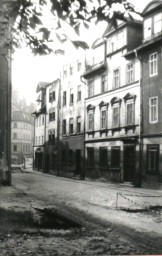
[147,144,159,172]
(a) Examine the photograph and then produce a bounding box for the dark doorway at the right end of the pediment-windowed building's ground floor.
[123,145,136,182]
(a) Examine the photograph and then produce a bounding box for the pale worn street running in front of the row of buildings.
[9,172,162,236]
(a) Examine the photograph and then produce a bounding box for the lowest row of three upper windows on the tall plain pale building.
[62,116,81,135]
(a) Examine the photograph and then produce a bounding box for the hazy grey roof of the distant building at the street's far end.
[12,111,34,124]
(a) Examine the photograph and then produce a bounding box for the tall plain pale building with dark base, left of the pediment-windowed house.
[60,50,85,176]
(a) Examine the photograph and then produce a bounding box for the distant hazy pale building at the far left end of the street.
[11,111,34,163]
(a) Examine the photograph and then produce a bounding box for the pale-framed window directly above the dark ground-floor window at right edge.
[149,97,158,124]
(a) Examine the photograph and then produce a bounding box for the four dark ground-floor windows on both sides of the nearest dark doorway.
[87,145,159,172]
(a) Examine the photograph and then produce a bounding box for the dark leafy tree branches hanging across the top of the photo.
[0,0,139,54]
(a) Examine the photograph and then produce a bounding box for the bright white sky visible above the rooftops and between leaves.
[12,0,150,104]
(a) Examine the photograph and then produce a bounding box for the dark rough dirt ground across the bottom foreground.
[0,208,162,256]
